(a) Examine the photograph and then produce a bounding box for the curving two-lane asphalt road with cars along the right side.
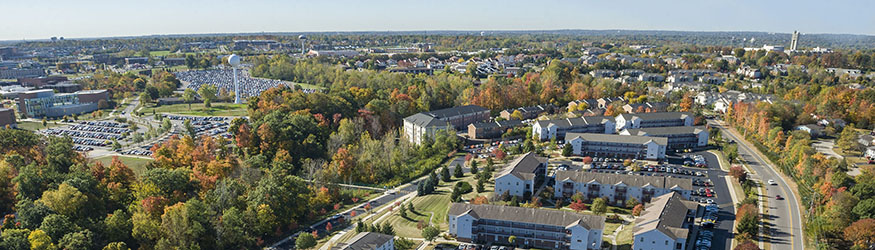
[708,120,805,250]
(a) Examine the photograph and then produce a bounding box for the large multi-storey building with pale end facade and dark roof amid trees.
[404,105,489,144]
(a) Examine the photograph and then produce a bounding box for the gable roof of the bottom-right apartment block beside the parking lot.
[633,192,698,240]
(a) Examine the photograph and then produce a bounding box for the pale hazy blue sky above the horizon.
[0,0,875,40]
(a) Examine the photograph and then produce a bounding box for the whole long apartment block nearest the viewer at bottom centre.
[447,203,605,250]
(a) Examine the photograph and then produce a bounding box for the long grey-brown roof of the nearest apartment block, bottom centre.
[447,203,605,230]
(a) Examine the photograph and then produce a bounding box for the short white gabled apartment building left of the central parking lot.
[495,153,547,197]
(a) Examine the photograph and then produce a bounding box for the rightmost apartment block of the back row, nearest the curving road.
[620,126,709,150]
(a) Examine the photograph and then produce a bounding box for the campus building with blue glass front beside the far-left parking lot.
[18,89,109,117]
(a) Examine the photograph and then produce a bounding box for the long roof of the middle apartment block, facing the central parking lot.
[556,170,693,190]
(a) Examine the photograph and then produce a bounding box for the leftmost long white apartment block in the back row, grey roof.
[532,116,616,141]
